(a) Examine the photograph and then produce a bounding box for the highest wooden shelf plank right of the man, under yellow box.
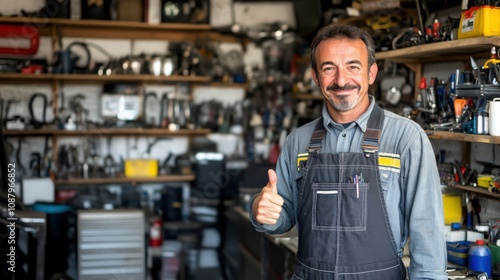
[376,36,500,63]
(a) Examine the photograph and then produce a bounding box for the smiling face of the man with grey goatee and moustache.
[313,38,377,116]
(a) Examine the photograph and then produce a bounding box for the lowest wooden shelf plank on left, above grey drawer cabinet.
[54,175,195,187]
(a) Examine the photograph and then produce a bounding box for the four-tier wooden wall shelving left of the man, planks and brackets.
[0,17,238,186]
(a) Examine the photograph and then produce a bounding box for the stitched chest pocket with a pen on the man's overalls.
[312,183,369,231]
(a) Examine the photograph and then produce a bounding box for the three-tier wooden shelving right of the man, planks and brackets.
[376,36,500,199]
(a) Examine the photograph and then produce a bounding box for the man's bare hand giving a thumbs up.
[252,169,284,225]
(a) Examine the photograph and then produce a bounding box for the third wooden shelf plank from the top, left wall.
[3,128,210,137]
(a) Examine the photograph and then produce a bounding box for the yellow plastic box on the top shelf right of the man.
[458,6,500,39]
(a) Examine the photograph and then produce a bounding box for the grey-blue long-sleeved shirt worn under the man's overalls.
[250,96,447,280]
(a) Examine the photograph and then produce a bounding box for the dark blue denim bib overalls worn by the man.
[293,104,406,280]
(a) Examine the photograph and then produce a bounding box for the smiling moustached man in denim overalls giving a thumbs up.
[250,25,447,280]
